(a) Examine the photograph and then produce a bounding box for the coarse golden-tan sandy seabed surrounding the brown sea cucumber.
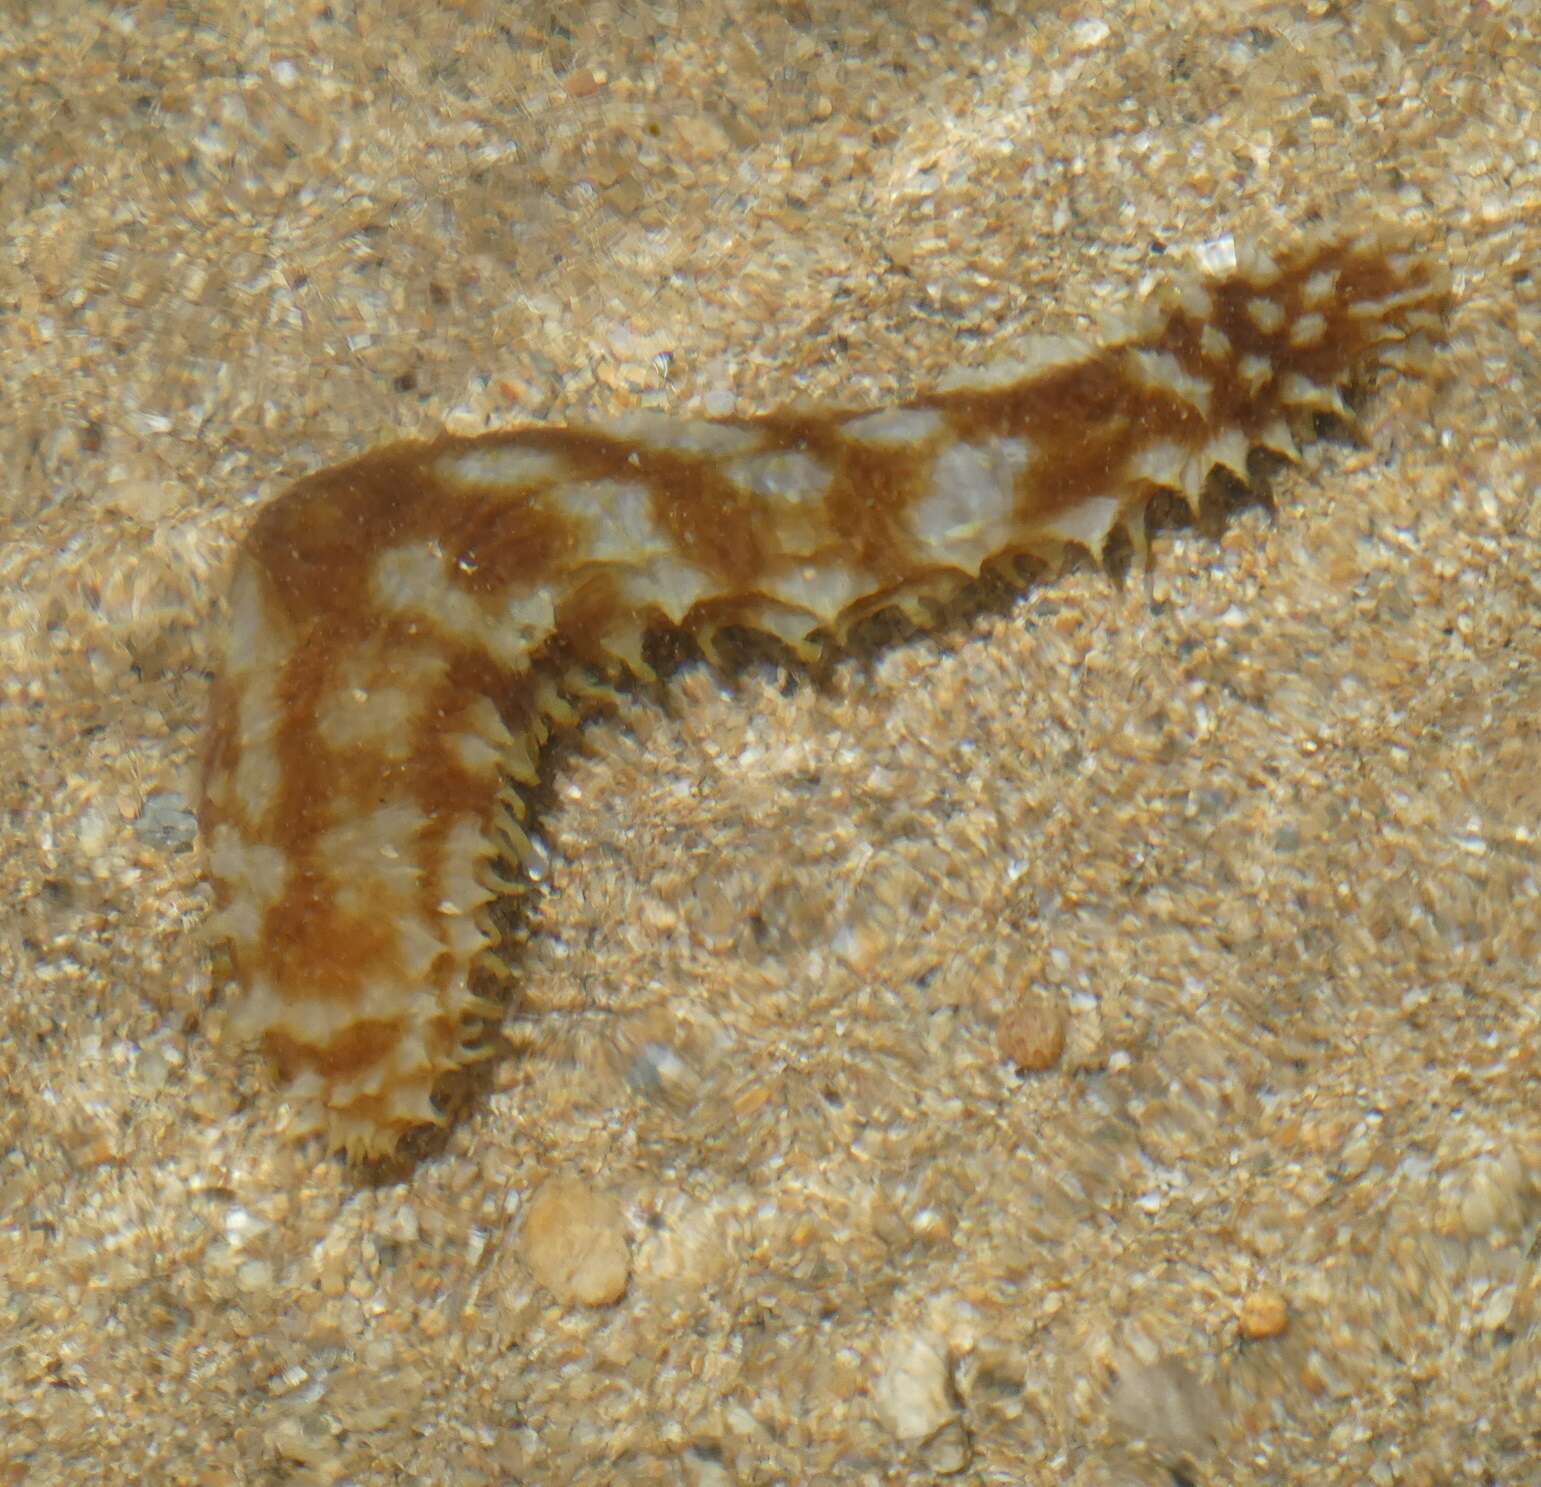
[0,0,1541,1487]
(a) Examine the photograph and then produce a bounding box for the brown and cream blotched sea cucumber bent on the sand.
[202,236,1449,1157]
